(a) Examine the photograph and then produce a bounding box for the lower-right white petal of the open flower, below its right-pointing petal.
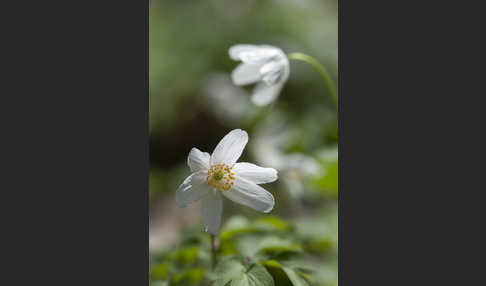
[222,177,275,213]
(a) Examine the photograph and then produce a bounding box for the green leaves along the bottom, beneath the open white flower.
[150,208,337,286]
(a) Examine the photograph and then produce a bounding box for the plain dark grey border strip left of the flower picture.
[0,0,149,286]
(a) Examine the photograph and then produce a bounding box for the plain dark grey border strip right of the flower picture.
[339,0,470,286]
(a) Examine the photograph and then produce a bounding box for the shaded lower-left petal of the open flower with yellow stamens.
[176,171,212,208]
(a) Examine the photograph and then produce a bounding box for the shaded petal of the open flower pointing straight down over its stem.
[201,191,223,235]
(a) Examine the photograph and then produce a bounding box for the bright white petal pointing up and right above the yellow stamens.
[211,129,248,166]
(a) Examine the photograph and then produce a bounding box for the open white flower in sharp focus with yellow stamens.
[176,129,277,235]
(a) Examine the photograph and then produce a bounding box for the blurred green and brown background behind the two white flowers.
[149,0,338,285]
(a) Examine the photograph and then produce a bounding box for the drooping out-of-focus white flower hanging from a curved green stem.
[229,45,290,106]
